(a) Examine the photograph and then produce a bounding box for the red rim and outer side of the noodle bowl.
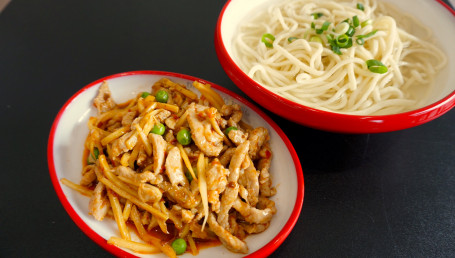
[214,0,455,133]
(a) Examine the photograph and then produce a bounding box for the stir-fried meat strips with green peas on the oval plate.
[61,78,277,257]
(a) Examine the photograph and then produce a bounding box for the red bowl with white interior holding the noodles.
[215,0,455,133]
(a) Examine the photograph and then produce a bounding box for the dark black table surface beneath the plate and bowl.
[0,0,455,257]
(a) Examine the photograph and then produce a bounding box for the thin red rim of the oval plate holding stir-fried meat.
[47,71,304,257]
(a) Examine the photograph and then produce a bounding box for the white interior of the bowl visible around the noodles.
[221,0,455,110]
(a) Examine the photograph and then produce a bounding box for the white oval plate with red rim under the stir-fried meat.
[48,71,304,257]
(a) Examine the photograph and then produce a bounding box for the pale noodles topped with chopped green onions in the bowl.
[233,0,447,115]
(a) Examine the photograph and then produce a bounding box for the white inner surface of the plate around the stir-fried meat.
[53,74,297,257]
